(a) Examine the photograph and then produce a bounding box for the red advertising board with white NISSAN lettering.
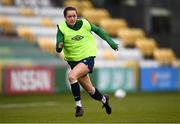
[4,67,54,95]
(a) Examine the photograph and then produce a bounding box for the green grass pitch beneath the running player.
[0,93,180,123]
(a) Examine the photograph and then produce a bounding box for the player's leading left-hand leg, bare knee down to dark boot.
[68,63,89,117]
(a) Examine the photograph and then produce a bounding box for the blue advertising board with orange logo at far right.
[140,67,178,91]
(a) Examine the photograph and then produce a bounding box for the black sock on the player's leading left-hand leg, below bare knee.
[71,82,81,101]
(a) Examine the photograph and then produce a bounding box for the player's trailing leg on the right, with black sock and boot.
[78,75,111,114]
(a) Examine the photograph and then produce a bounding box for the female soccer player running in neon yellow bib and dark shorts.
[56,7,118,117]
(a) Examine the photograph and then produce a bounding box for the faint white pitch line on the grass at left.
[0,101,56,109]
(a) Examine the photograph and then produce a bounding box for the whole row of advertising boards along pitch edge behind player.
[0,65,180,95]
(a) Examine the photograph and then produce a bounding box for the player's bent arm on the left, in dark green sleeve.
[56,25,64,53]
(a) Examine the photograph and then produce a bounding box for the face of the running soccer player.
[65,10,77,26]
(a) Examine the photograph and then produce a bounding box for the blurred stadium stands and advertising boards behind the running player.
[0,0,180,95]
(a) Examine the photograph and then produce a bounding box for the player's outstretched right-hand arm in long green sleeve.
[91,24,118,50]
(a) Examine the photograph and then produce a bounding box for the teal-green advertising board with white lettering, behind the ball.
[95,67,137,92]
